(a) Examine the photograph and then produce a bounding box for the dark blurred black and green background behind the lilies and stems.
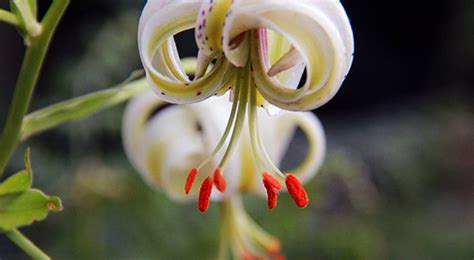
[0,0,474,260]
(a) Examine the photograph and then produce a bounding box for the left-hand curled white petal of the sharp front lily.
[138,0,228,104]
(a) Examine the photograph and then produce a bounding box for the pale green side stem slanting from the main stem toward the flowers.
[21,75,149,140]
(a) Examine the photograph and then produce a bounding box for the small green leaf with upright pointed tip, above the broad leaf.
[0,149,33,195]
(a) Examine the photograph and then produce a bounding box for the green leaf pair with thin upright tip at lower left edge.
[0,150,62,231]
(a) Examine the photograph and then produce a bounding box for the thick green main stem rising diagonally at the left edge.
[0,0,69,178]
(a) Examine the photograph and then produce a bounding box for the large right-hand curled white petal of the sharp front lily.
[224,0,353,110]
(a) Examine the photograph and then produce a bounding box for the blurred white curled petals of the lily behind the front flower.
[122,92,326,208]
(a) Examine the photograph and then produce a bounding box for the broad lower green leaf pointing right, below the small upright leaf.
[0,189,63,230]
